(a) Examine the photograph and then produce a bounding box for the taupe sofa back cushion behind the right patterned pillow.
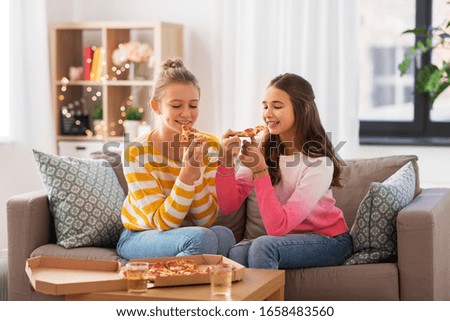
[333,155,420,226]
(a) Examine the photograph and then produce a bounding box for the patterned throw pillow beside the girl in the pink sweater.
[344,162,416,265]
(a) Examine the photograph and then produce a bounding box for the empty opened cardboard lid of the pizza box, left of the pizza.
[25,256,127,295]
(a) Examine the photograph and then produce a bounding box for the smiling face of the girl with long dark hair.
[262,86,295,142]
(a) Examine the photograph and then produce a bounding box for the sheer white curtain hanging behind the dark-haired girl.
[215,0,358,157]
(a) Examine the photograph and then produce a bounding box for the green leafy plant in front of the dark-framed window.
[398,20,450,108]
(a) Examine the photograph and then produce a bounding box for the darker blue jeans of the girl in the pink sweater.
[229,232,353,269]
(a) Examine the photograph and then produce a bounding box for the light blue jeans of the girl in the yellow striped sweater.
[117,226,236,260]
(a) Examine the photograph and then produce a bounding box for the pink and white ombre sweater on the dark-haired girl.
[216,153,348,236]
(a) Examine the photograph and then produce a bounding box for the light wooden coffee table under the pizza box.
[66,269,285,301]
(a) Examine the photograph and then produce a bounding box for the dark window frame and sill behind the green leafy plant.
[359,0,450,146]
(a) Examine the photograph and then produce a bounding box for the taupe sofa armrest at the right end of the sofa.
[397,188,450,300]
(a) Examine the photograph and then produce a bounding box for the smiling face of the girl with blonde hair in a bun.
[151,83,200,134]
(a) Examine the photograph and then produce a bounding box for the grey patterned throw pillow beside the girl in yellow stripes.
[33,150,125,248]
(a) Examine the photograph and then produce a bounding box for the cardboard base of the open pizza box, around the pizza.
[130,254,245,288]
